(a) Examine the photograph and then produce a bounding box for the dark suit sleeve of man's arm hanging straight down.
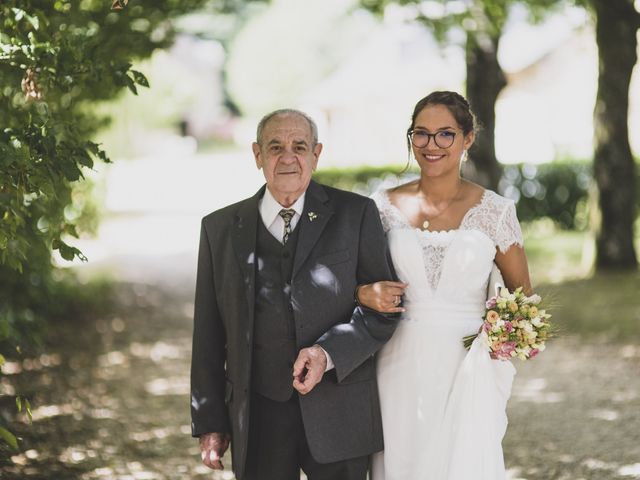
[191,220,230,437]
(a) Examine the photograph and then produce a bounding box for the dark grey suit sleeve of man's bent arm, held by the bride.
[317,200,400,382]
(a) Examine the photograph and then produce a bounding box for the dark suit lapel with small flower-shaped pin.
[291,182,333,278]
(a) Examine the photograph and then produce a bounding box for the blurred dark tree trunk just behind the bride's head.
[463,33,507,190]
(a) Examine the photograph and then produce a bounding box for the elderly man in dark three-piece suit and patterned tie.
[191,109,397,480]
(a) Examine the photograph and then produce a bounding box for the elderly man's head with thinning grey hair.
[252,114,322,206]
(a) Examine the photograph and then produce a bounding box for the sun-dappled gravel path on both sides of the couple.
[0,284,640,480]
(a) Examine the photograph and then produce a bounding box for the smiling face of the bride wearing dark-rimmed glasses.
[411,105,473,177]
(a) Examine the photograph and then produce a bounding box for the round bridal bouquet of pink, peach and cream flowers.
[463,287,551,360]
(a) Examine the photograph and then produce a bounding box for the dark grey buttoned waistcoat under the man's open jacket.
[252,219,300,401]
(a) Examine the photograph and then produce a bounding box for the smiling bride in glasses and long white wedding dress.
[357,91,531,480]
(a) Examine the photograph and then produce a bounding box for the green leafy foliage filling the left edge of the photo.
[0,0,255,446]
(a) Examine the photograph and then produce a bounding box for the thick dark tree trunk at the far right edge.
[591,0,640,271]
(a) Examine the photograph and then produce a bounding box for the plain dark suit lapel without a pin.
[233,187,265,328]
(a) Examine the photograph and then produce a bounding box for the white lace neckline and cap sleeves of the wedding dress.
[372,190,523,292]
